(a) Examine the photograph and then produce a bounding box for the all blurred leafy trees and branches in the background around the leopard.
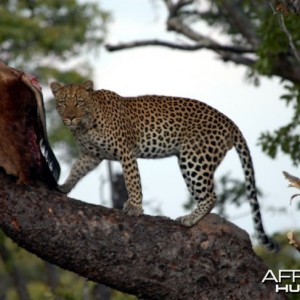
[0,0,300,299]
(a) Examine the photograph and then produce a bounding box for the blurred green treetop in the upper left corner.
[0,0,108,82]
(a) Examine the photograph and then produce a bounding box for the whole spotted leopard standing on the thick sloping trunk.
[50,80,278,252]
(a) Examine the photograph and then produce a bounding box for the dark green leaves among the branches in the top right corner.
[209,0,300,75]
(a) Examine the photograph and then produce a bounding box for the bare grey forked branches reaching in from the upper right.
[106,0,300,83]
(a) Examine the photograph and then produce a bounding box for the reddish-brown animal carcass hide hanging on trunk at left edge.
[0,62,60,187]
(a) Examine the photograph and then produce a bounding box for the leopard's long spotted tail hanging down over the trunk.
[233,127,279,252]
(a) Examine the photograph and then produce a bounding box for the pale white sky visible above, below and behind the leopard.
[58,0,300,243]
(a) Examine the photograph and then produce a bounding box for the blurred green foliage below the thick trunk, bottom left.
[0,231,136,300]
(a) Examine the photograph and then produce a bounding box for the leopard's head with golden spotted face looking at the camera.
[50,80,93,129]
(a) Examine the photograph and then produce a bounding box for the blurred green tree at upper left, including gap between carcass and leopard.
[0,0,109,161]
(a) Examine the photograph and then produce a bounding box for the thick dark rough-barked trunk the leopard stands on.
[0,172,285,300]
